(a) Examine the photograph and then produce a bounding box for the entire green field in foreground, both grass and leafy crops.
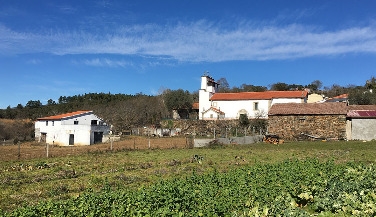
[0,141,376,216]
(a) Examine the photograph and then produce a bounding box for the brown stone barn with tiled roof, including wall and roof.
[268,103,348,140]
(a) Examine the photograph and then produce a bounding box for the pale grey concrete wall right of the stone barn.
[351,119,376,141]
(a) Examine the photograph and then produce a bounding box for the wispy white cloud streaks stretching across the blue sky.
[0,21,376,61]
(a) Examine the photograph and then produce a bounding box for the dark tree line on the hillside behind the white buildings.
[0,77,376,141]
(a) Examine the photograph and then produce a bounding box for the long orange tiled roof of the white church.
[210,90,308,101]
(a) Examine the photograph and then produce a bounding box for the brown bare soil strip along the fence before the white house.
[0,137,189,161]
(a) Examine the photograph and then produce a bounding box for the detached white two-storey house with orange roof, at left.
[35,111,110,146]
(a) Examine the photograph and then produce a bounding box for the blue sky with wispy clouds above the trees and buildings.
[0,0,376,109]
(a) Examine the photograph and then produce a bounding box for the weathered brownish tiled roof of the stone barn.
[268,102,347,115]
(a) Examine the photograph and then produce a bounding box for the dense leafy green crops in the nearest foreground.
[0,159,376,216]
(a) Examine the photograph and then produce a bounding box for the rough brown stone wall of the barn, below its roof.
[268,115,346,140]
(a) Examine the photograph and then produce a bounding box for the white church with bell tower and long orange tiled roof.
[199,74,308,120]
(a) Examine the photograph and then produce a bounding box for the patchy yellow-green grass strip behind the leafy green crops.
[0,141,376,211]
